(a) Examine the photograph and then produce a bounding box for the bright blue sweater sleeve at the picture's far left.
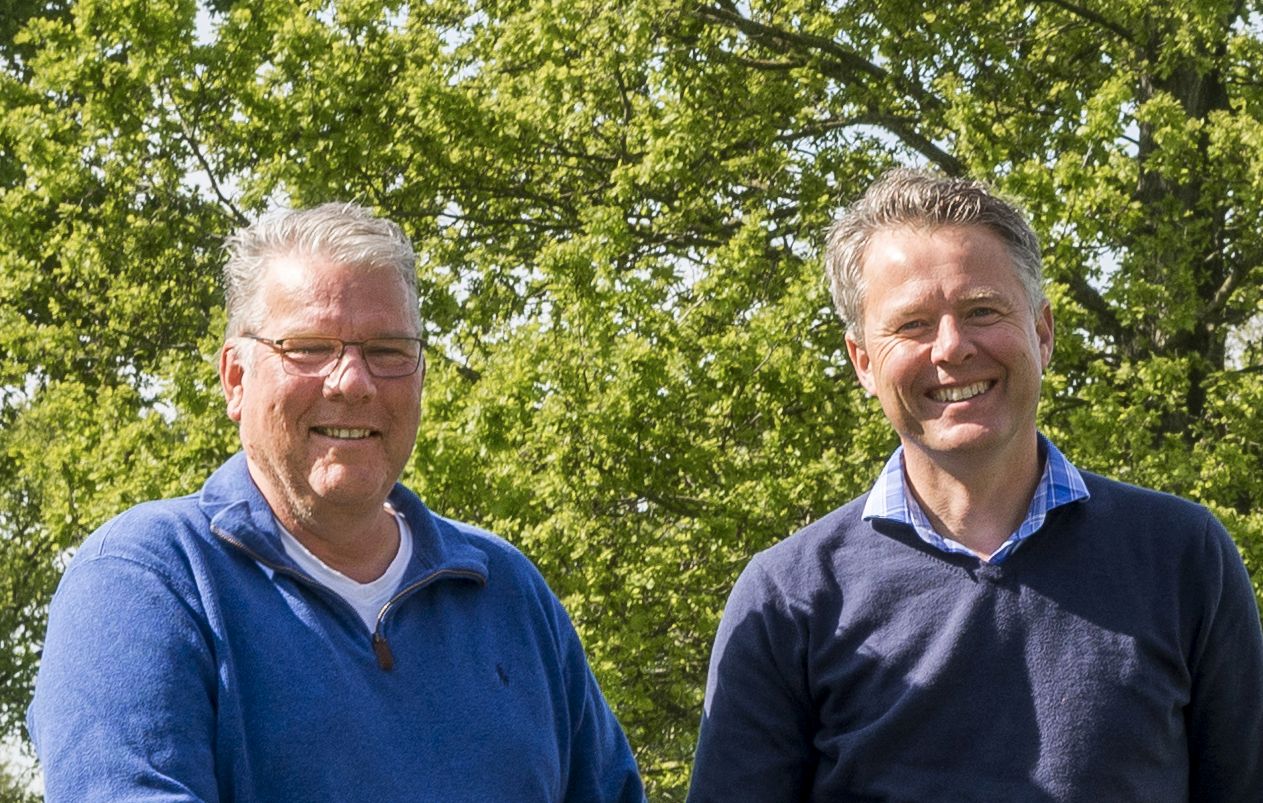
[27,556,218,803]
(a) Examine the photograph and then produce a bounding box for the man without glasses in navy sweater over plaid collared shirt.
[690,170,1263,803]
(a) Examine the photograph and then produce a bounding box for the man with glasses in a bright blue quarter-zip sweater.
[28,205,644,803]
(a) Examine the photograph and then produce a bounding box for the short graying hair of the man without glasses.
[825,168,1046,343]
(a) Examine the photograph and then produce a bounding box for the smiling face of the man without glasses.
[846,226,1052,468]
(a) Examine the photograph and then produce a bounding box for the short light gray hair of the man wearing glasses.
[224,203,421,338]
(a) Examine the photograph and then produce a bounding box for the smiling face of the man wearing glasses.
[220,256,424,533]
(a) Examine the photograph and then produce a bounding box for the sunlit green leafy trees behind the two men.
[0,0,1263,800]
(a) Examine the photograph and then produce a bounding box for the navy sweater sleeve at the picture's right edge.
[1185,515,1263,800]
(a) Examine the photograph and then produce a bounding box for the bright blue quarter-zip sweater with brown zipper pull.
[28,455,644,803]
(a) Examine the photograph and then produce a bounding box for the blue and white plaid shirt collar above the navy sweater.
[864,436,1087,563]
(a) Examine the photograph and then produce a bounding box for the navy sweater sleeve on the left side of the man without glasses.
[688,558,816,803]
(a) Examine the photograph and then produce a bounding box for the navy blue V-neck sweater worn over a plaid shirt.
[690,473,1263,803]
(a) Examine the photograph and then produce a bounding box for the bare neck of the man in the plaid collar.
[903,437,1043,558]
